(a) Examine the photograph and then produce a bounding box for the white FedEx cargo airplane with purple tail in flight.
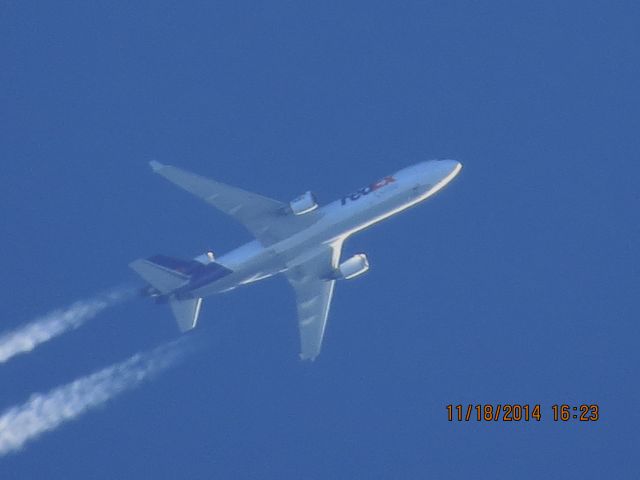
[129,160,462,360]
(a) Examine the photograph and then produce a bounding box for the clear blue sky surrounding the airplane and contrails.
[0,1,640,479]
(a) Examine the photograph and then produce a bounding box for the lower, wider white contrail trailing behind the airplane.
[0,337,193,456]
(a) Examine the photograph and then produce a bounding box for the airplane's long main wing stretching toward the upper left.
[149,160,319,245]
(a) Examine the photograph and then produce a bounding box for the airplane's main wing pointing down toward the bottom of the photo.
[285,241,342,360]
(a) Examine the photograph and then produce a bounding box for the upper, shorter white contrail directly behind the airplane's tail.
[0,288,132,364]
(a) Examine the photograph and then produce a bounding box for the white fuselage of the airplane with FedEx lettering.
[192,160,462,297]
